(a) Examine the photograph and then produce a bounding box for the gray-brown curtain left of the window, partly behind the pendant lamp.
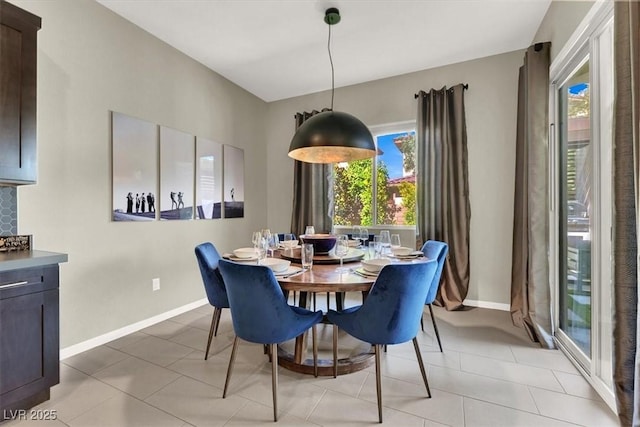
[291,109,333,236]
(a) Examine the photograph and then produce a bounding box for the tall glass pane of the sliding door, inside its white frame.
[557,60,594,360]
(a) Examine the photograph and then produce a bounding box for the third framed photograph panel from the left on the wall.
[196,137,222,219]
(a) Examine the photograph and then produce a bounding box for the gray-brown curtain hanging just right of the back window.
[416,84,471,310]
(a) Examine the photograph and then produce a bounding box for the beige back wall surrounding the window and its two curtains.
[267,51,524,304]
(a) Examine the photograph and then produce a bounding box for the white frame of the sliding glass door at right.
[549,2,616,411]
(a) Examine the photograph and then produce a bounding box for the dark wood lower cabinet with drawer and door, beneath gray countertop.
[0,264,60,416]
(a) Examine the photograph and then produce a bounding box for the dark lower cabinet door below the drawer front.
[0,289,59,408]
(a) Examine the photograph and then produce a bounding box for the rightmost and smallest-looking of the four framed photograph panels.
[224,145,244,218]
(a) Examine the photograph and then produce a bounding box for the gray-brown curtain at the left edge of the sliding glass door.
[511,42,555,348]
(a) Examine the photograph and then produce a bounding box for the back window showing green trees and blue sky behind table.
[333,122,416,226]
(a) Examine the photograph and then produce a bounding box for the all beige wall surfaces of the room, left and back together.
[12,0,600,348]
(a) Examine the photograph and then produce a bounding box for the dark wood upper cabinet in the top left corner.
[0,0,41,184]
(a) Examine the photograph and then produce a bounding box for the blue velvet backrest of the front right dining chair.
[344,260,437,344]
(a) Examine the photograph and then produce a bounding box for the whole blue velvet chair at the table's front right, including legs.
[327,260,437,422]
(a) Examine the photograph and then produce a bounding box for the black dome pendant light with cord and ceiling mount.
[289,8,376,163]
